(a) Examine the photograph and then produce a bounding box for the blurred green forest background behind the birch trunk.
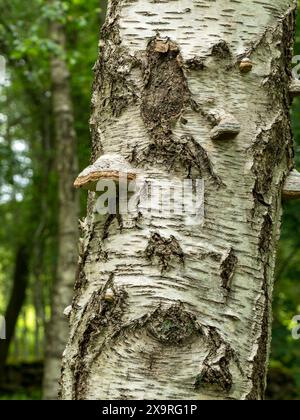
[0,0,300,400]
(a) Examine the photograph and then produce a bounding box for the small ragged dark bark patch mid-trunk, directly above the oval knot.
[145,233,184,273]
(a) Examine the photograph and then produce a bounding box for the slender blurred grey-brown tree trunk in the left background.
[43,17,79,400]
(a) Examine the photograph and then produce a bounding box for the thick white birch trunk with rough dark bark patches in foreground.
[61,0,296,400]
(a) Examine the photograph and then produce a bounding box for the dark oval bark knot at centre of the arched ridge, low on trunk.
[147,304,202,345]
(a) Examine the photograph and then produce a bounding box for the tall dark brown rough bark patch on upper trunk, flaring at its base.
[134,38,222,186]
